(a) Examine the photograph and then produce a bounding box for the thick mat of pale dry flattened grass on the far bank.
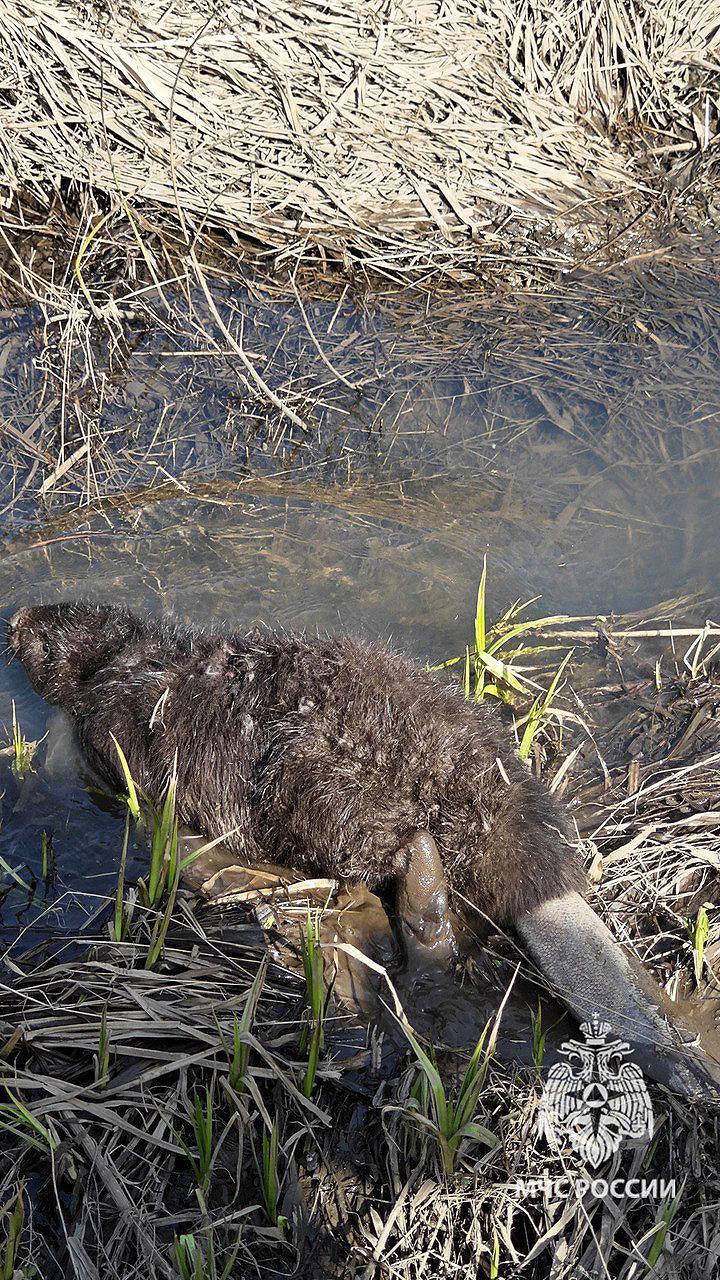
[0,0,720,280]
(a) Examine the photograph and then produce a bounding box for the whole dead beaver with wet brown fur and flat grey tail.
[8,602,720,1101]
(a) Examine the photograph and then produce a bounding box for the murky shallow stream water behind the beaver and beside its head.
[0,246,720,1049]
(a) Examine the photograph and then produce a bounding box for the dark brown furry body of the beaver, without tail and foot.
[9,603,579,923]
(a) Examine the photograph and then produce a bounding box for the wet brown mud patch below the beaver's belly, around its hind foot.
[182,831,571,1065]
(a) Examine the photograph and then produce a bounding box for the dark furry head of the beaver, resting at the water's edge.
[8,603,142,707]
